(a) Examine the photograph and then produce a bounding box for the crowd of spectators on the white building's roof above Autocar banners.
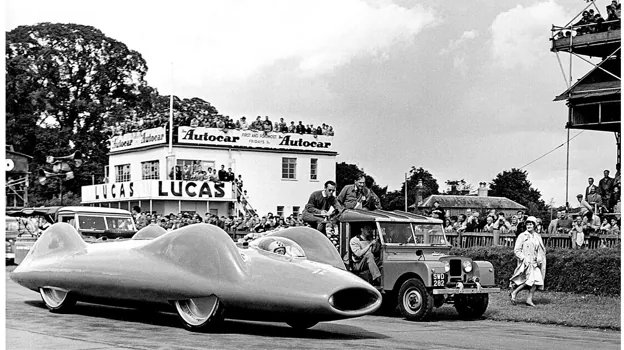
[110,113,334,136]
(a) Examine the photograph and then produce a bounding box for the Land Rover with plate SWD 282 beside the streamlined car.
[339,209,500,321]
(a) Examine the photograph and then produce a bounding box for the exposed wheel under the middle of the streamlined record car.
[173,295,223,332]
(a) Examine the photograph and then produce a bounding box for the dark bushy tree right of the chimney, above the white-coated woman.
[490,168,546,215]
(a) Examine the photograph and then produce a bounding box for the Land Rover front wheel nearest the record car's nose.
[397,278,433,321]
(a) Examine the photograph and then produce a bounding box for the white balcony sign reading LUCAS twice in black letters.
[82,180,235,203]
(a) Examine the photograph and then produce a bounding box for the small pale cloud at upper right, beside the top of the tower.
[490,1,574,69]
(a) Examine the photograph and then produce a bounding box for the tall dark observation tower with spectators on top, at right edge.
[550,1,622,204]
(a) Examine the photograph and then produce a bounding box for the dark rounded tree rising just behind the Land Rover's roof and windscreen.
[381,166,439,210]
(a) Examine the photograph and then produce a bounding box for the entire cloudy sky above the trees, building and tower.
[5,0,616,205]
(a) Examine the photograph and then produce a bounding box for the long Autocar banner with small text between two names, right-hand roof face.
[178,126,333,151]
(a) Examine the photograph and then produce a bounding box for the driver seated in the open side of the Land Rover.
[349,225,381,285]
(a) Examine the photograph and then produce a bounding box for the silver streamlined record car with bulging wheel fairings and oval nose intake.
[10,223,381,331]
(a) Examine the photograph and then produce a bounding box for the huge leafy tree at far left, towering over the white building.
[5,23,147,200]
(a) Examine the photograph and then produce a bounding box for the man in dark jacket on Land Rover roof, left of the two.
[303,180,342,234]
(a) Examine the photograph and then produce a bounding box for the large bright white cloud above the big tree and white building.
[7,0,436,87]
